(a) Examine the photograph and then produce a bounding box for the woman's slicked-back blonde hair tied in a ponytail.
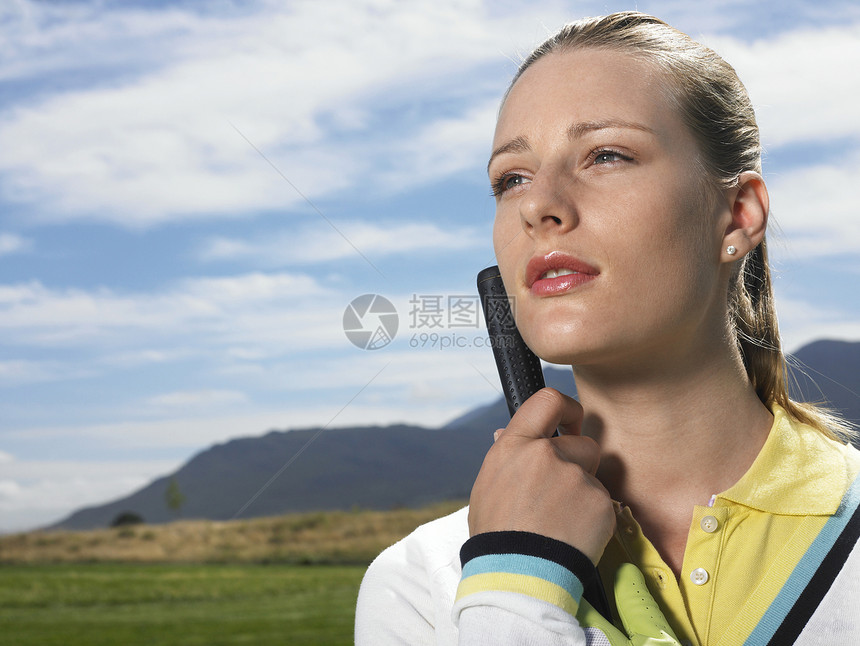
[508,11,854,441]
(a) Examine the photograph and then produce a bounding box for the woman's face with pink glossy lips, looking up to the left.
[489,49,731,372]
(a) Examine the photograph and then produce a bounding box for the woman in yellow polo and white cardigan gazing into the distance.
[356,12,860,645]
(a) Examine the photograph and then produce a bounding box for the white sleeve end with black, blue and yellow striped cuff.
[453,532,596,646]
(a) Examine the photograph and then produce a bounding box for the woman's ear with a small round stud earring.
[721,171,770,262]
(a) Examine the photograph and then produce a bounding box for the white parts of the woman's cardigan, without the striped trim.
[355,508,860,646]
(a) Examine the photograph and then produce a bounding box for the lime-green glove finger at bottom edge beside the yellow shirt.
[615,563,678,646]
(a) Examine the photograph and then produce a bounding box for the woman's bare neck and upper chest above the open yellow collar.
[574,340,773,575]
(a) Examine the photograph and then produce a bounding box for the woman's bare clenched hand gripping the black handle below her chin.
[469,388,615,563]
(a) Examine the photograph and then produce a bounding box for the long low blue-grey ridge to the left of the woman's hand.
[53,425,492,529]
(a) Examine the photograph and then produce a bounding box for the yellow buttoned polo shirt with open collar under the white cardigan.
[598,405,860,646]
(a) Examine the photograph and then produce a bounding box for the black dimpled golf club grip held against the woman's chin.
[478,265,612,622]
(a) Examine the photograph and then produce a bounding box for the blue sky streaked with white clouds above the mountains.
[0,0,860,531]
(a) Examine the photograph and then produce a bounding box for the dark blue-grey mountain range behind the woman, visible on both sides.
[54,341,860,529]
